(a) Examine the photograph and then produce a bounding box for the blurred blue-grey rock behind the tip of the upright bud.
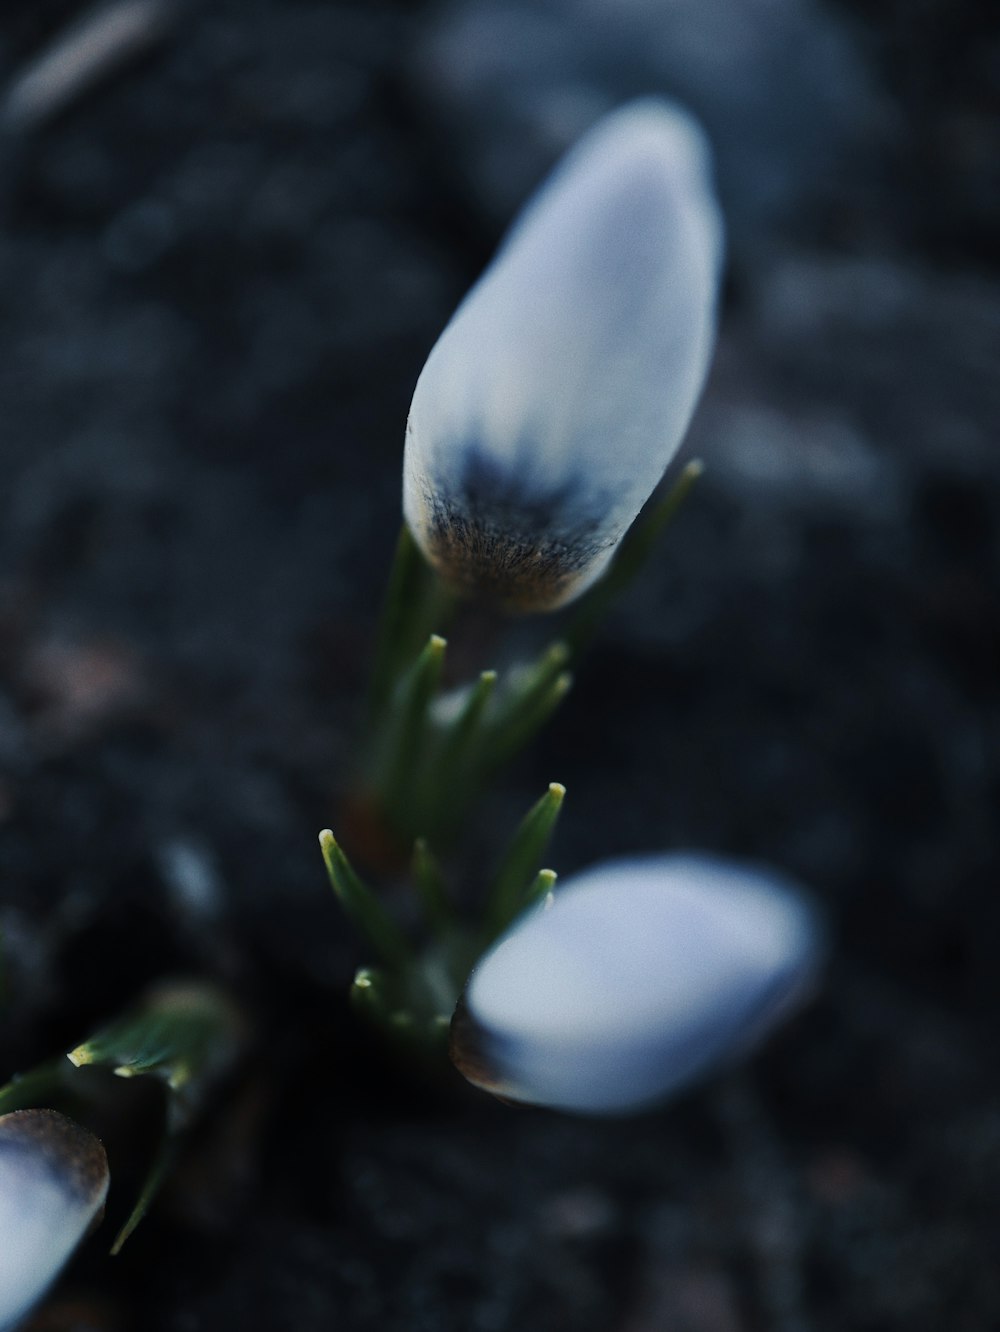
[414,0,891,253]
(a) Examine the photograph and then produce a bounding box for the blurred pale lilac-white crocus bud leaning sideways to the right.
[451,855,820,1114]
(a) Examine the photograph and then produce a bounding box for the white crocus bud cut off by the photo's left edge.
[0,1110,108,1329]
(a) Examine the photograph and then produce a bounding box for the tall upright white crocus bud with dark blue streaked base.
[403,99,722,610]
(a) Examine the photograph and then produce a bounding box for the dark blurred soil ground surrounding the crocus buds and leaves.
[0,0,1000,1332]
